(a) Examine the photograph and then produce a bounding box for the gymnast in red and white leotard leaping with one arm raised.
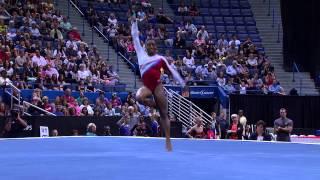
[131,16,185,151]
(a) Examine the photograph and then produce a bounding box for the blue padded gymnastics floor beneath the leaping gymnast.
[0,137,320,180]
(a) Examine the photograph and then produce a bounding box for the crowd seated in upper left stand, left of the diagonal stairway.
[0,0,120,91]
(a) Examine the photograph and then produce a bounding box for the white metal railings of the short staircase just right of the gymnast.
[164,88,212,128]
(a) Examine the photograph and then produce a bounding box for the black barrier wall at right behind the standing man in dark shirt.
[230,95,320,129]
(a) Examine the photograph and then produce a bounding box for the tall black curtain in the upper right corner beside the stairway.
[281,0,320,74]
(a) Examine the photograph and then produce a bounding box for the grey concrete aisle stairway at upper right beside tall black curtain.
[248,0,319,95]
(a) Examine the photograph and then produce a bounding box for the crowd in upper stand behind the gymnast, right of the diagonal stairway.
[82,1,285,95]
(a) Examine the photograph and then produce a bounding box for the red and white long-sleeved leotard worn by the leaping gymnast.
[131,22,185,92]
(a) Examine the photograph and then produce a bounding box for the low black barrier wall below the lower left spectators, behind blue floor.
[0,116,182,137]
